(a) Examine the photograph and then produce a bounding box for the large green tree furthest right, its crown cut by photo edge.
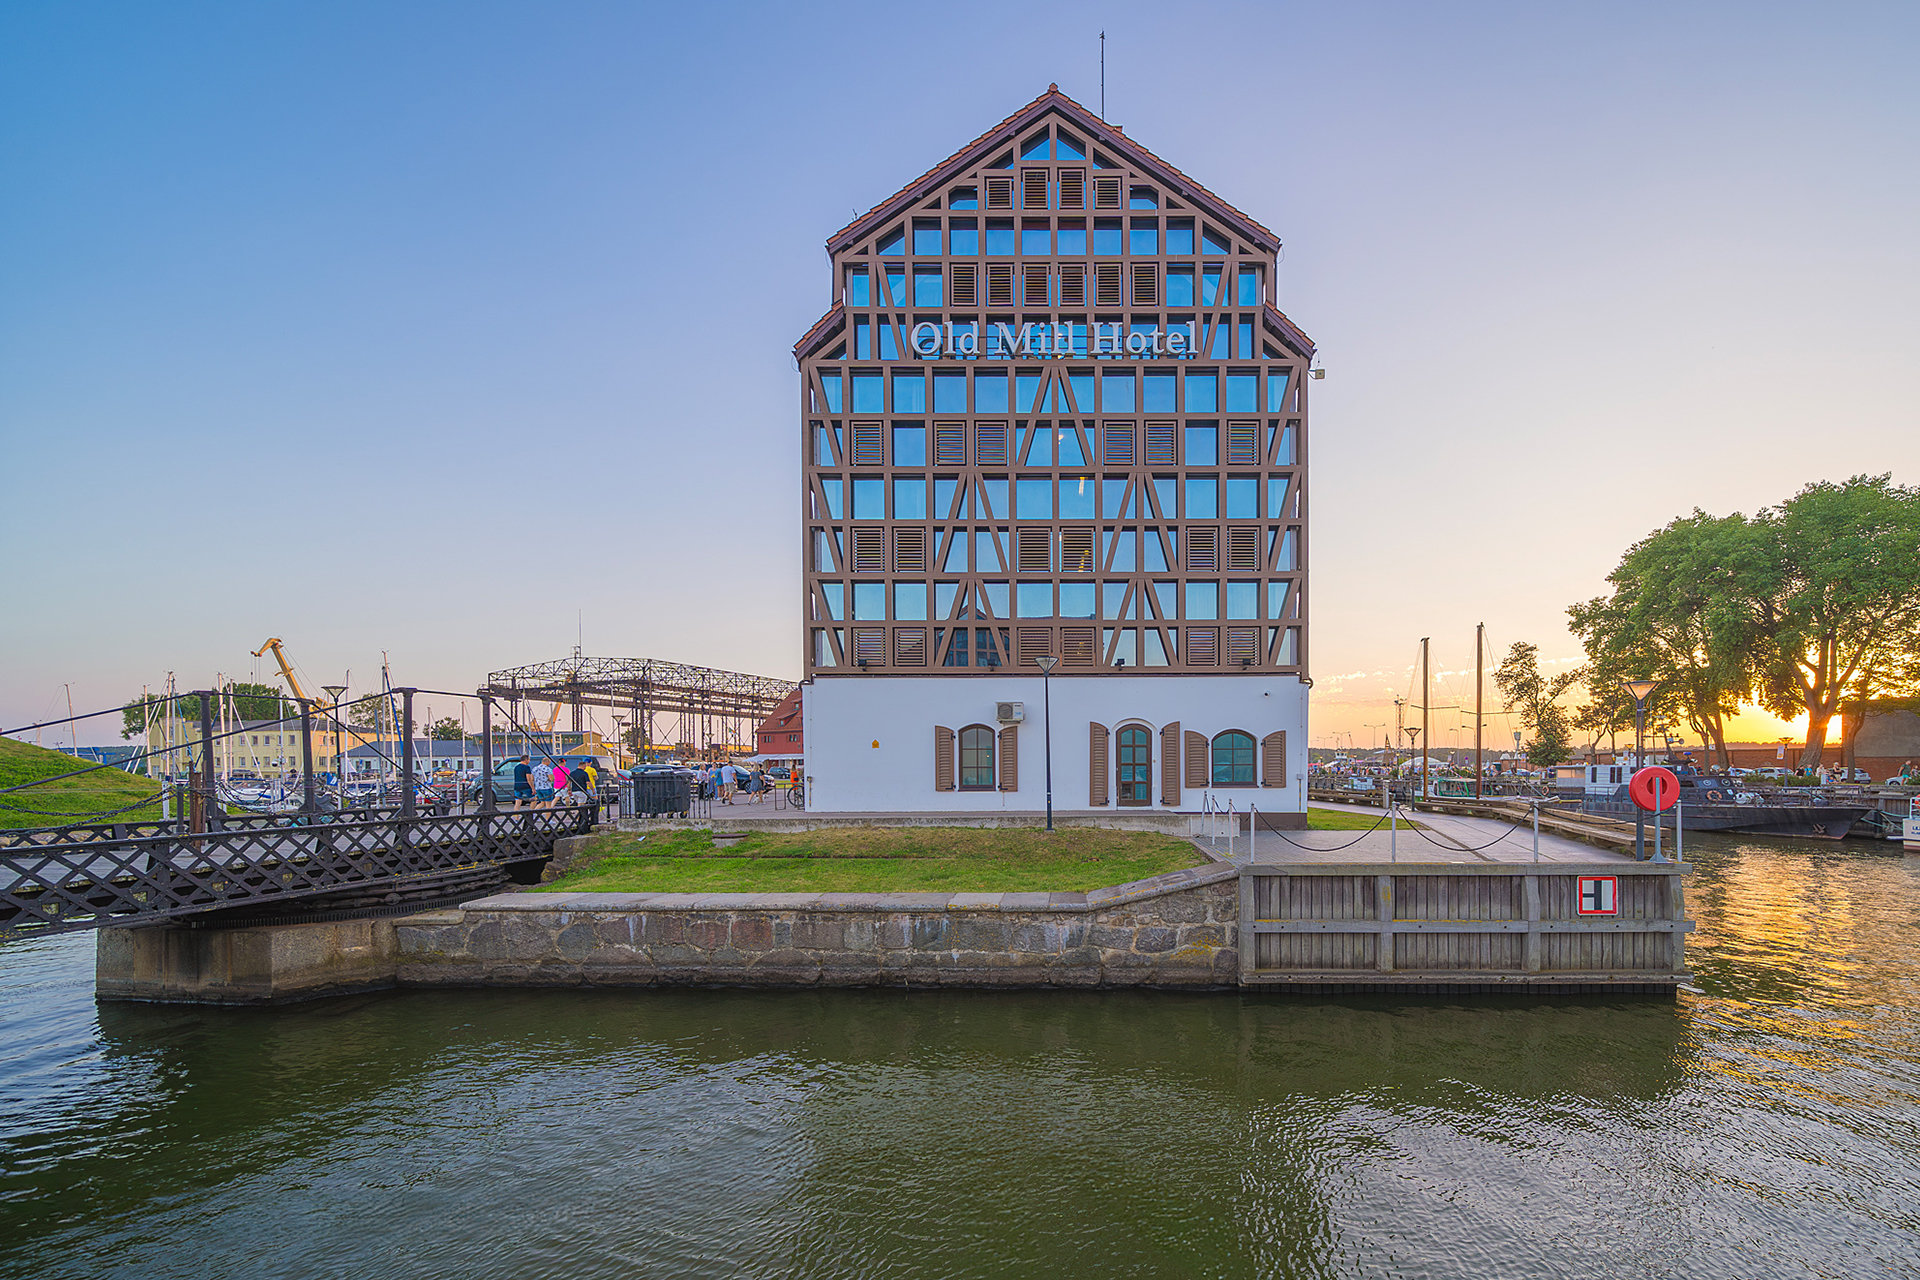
[1738,474,1920,770]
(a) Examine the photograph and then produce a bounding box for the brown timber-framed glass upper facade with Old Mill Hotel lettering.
[797,109,1311,675]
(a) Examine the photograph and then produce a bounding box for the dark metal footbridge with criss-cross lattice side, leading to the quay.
[0,804,599,940]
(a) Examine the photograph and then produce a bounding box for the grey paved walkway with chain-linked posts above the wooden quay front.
[1206,802,1632,862]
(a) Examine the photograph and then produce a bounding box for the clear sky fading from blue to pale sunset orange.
[0,0,1920,747]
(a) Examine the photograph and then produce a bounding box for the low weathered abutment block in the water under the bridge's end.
[94,919,396,1004]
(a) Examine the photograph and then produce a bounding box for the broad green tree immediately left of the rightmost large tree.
[1567,509,1766,764]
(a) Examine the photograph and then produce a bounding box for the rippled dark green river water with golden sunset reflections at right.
[0,839,1920,1280]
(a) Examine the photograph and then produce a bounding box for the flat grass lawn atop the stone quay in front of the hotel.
[541,827,1204,892]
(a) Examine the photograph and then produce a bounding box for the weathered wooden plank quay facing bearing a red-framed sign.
[1240,862,1693,988]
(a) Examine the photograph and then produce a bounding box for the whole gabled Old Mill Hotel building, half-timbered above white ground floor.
[795,88,1313,816]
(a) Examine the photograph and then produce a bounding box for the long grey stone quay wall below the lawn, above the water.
[394,864,1240,988]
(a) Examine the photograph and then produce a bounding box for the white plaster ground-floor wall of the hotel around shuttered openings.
[801,674,1308,814]
